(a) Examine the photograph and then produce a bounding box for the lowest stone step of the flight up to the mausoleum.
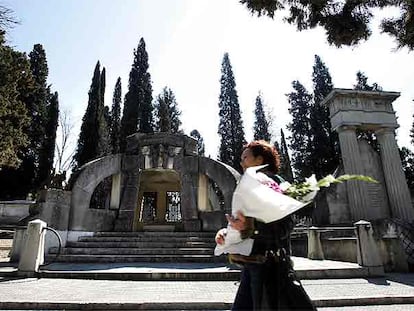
[45,254,227,263]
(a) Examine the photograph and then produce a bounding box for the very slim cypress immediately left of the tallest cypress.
[109,77,122,154]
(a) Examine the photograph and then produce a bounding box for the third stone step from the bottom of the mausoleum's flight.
[66,241,216,248]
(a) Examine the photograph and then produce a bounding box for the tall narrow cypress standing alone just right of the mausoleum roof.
[218,53,246,171]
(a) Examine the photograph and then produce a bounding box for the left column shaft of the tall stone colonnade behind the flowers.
[337,126,366,221]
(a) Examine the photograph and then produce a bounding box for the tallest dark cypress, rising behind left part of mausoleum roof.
[121,38,154,151]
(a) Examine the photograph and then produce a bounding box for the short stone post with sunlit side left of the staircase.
[18,219,47,274]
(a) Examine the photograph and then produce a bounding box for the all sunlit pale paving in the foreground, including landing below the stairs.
[0,257,414,311]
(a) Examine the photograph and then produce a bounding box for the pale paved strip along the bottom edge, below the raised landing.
[0,274,414,311]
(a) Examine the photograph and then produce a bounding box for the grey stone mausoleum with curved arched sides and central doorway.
[40,133,240,245]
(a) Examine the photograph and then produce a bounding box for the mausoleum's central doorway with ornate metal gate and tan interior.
[134,169,182,231]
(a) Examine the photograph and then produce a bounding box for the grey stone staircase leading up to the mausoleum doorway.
[46,232,226,263]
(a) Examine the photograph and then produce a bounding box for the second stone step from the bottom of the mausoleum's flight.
[49,247,213,256]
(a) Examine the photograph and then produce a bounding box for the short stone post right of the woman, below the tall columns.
[354,220,384,276]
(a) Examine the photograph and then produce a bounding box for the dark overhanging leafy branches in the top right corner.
[240,0,414,50]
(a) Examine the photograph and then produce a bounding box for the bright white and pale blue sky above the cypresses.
[4,0,414,158]
